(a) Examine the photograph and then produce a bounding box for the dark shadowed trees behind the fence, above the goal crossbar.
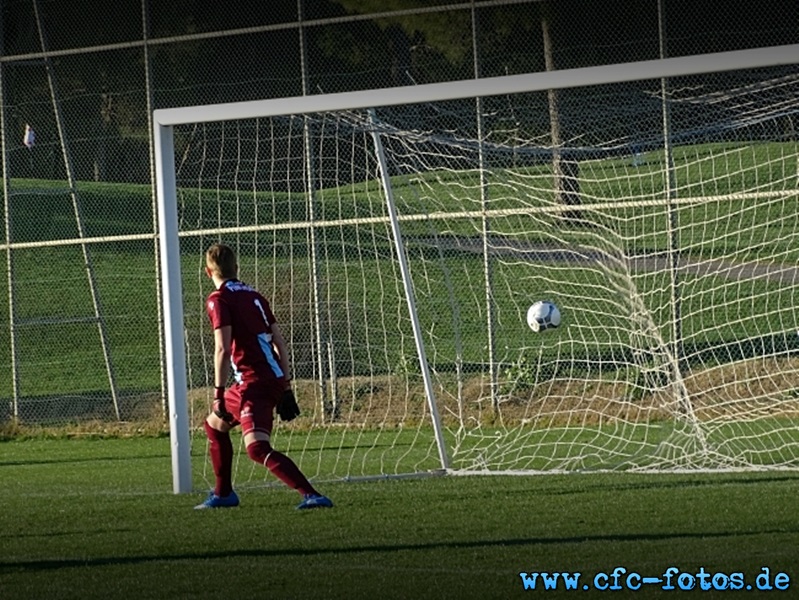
[2,0,799,181]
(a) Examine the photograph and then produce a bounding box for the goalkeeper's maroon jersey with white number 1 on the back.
[205,279,283,385]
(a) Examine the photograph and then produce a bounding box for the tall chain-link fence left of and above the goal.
[0,0,799,423]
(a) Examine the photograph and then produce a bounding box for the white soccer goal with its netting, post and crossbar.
[156,47,799,491]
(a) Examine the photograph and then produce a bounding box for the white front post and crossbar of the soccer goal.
[153,44,799,494]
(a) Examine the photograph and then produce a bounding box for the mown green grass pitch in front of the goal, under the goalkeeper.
[0,438,799,600]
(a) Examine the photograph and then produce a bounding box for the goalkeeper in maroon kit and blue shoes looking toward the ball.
[195,244,333,509]
